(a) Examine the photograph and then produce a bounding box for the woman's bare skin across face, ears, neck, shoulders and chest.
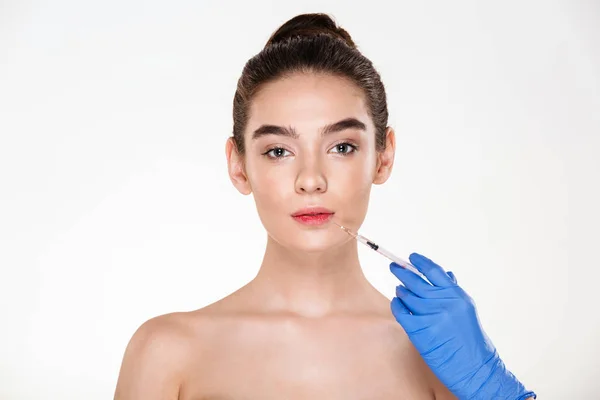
[115,74,455,400]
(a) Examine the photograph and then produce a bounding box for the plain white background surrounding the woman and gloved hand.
[0,0,600,400]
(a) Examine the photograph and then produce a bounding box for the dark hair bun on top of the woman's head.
[265,13,356,48]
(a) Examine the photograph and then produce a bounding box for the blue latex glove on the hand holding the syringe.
[390,253,536,400]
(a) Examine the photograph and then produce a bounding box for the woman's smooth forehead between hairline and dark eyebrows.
[247,73,372,132]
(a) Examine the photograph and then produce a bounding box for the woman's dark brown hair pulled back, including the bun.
[233,14,388,154]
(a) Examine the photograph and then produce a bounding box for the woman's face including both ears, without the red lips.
[227,73,395,251]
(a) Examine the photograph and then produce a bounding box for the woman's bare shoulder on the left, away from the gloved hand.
[115,313,200,400]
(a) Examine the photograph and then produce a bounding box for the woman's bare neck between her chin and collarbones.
[251,233,382,317]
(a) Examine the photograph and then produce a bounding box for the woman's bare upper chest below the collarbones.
[180,324,435,400]
